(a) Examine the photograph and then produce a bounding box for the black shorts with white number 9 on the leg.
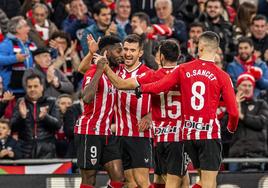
[75,134,121,170]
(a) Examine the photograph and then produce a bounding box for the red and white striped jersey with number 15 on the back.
[136,67,182,142]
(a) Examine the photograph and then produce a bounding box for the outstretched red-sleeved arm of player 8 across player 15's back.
[140,66,180,94]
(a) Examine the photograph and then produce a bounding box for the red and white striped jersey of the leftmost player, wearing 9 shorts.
[74,65,115,135]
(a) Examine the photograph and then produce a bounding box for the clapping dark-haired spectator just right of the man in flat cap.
[49,31,80,86]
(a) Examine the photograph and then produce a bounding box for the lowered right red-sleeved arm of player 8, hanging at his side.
[222,75,239,133]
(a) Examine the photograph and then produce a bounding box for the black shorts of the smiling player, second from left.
[119,136,152,170]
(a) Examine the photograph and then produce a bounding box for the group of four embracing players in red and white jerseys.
[75,31,238,188]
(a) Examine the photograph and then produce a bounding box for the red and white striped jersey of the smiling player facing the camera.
[115,63,152,138]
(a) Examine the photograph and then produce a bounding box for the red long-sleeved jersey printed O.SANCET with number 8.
[141,59,239,140]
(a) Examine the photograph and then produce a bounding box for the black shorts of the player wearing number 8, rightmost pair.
[184,139,222,171]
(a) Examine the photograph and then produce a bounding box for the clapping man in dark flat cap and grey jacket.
[23,48,73,98]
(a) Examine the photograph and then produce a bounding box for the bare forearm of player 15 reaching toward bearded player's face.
[104,65,138,90]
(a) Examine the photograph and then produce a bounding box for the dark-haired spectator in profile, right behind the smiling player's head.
[131,12,158,70]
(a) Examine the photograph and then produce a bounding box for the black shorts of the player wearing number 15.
[154,142,187,176]
